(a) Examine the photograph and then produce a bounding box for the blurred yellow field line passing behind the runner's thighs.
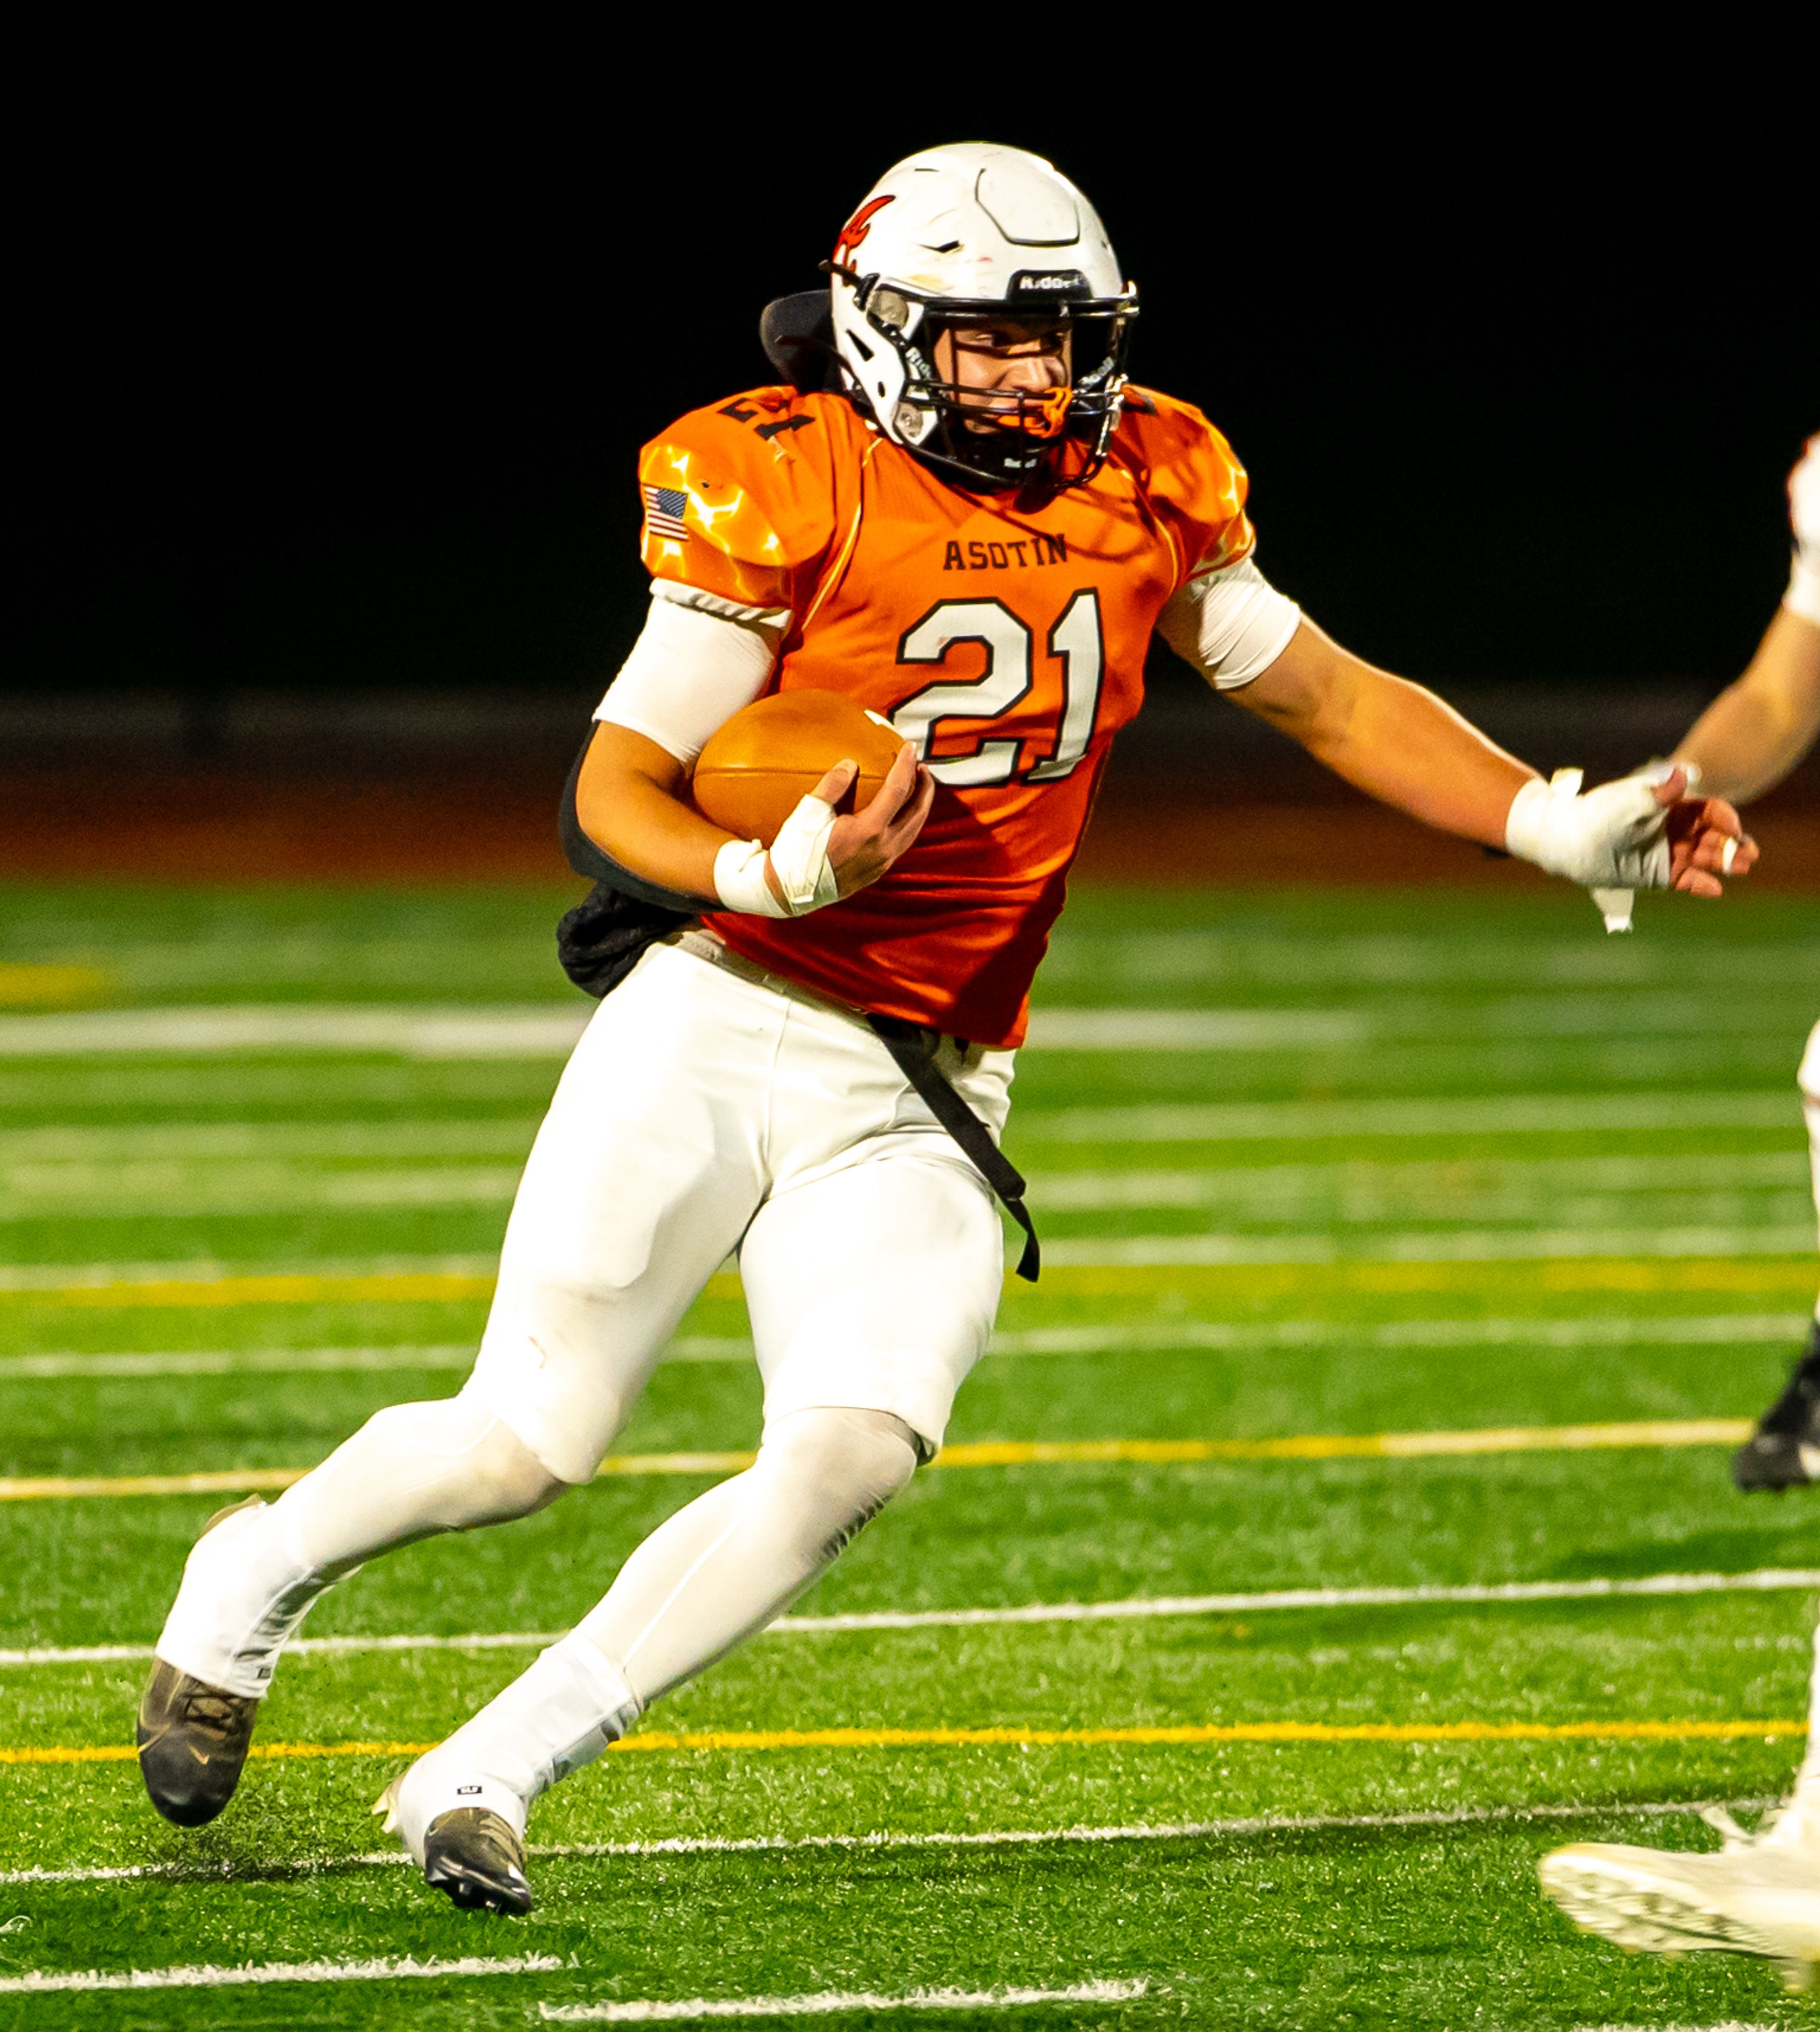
[0,1258,1814,1311]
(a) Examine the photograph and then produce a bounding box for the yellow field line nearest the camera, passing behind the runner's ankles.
[10,1721,1808,1764]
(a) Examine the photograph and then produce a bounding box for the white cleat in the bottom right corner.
[1540,1806,1820,1989]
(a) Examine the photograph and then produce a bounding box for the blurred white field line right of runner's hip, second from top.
[1014,1081,1802,1142]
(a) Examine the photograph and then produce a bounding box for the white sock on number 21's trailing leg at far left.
[156,1396,567,1699]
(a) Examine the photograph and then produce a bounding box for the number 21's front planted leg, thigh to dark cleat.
[382,1039,1003,1912]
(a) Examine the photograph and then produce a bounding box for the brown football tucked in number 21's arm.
[691,691,904,845]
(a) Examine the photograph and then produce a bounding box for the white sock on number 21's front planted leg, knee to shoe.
[388,1410,918,1861]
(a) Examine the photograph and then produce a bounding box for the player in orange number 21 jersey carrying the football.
[140,144,1755,1912]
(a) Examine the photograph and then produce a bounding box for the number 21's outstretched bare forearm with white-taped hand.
[1231,618,1757,896]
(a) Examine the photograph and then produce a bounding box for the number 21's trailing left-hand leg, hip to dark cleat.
[138,949,782,1827]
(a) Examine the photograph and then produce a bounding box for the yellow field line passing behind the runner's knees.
[0,1418,1753,1503]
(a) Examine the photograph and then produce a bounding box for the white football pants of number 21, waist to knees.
[463,935,1011,1481]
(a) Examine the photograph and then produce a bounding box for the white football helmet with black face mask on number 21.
[829,142,1138,488]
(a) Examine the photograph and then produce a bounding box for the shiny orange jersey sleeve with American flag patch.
[638,388,835,628]
